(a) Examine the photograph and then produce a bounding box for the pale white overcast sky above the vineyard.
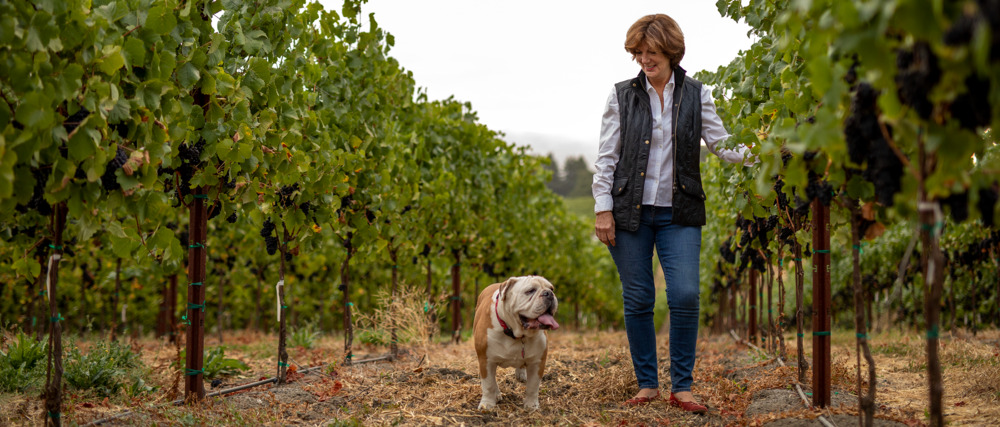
[322,0,751,164]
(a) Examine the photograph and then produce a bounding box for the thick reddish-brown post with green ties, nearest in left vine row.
[184,187,208,402]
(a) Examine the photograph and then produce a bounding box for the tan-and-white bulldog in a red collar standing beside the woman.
[472,276,559,411]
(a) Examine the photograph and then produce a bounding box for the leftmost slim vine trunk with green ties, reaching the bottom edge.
[45,203,66,427]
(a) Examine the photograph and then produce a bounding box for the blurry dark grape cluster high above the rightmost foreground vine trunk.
[896,42,941,120]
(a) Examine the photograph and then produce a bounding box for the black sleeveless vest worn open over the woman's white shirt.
[611,67,705,231]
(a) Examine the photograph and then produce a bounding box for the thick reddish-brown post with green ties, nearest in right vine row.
[810,198,831,408]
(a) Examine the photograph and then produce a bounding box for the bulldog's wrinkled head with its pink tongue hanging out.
[500,276,559,329]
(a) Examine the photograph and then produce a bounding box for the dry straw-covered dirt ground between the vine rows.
[0,329,1000,427]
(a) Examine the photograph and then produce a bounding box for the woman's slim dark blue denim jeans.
[608,206,701,393]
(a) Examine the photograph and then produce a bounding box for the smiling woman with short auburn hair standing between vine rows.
[593,14,753,413]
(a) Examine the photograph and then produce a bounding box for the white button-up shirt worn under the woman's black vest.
[592,78,756,213]
